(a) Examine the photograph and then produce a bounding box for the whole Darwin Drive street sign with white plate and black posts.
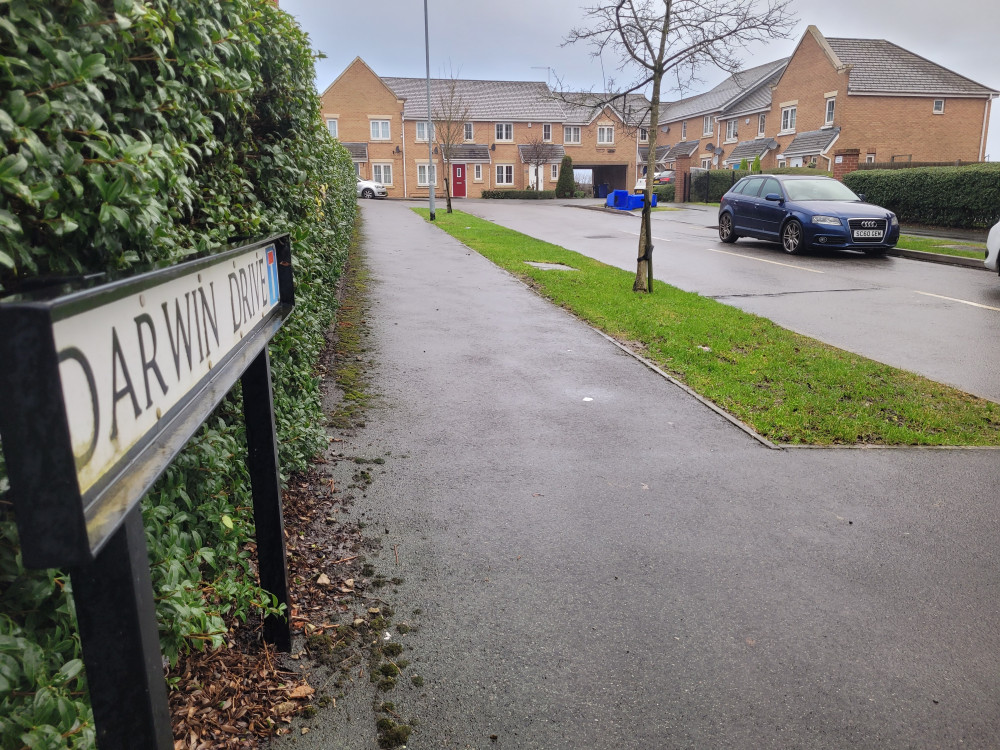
[0,235,294,750]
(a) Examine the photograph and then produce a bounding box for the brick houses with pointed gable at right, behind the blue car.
[660,26,1000,178]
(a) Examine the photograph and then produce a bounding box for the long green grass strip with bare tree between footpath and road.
[414,209,1000,445]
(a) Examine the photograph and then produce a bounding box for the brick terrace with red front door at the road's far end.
[321,57,649,198]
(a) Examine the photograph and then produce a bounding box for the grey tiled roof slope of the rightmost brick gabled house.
[826,38,998,96]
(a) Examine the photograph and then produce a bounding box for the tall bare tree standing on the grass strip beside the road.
[566,0,793,292]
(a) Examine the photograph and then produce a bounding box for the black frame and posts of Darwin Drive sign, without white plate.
[0,234,294,750]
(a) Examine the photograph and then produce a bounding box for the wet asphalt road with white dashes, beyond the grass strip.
[460,201,1000,401]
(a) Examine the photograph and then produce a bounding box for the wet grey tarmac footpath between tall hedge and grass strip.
[276,201,1000,750]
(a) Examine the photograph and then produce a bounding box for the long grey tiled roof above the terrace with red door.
[382,77,563,122]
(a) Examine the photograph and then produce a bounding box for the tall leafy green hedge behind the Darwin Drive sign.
[0,0,357,748]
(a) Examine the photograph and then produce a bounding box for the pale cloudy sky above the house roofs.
[279,0,1000,161]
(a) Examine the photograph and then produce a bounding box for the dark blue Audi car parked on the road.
[719,174,899,255]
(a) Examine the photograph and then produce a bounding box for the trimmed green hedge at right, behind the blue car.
[844,162,1000,229]
